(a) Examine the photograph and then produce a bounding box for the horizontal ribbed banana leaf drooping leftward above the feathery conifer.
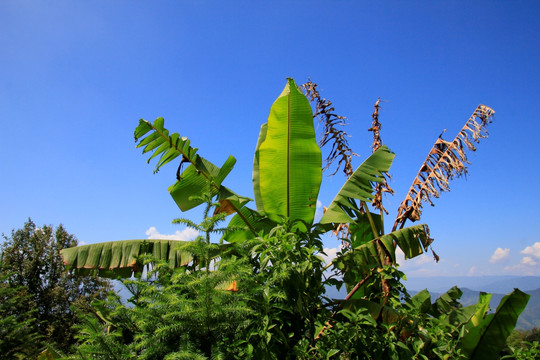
[60,239,193,279]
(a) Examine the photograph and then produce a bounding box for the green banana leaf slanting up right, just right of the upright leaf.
[320,145,395,224]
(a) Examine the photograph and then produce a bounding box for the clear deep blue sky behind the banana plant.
[0,0,540,276]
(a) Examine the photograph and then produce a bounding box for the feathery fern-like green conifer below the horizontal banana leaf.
[73,201,251,359]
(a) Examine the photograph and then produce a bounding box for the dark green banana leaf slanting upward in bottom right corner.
[460,289,530,360]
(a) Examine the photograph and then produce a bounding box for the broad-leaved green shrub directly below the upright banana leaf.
[226,222,329,359]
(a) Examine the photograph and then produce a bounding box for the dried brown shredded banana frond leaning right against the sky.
[393,105,495,230]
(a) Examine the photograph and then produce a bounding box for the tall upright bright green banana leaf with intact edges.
[253,79,322,224]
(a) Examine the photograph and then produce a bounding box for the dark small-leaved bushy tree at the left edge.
[0,220,110,353]
